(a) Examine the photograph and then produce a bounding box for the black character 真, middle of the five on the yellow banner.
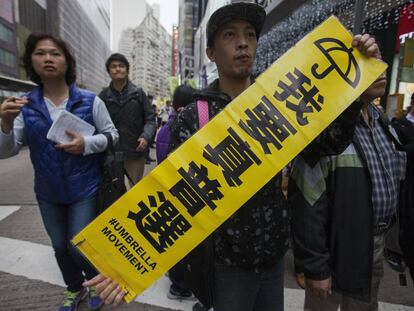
[203,127,262,187]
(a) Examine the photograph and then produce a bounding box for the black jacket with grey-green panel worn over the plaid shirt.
[288,109,406,301]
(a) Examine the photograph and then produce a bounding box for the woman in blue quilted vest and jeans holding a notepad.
[0,34,118,311]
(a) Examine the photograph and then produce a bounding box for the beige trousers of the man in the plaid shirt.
[304,234,385,311]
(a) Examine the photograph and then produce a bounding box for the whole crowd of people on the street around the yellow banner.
[0,1,414,311]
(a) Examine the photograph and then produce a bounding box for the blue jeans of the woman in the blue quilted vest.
[37,196,97,291]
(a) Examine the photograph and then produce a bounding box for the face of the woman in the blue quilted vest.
[32,39,68,81]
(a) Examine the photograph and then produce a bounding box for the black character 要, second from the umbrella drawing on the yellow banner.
[239,96,296,154]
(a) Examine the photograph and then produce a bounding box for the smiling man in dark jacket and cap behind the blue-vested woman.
[99,53,156,187]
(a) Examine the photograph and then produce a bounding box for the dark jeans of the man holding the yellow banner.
[213,258,285,311]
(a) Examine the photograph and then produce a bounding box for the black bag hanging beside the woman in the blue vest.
[98,133,126,213]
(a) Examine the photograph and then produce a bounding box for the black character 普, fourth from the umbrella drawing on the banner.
[170,161,223,216]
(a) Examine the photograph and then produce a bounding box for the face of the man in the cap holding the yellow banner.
[206,20,257,79]
